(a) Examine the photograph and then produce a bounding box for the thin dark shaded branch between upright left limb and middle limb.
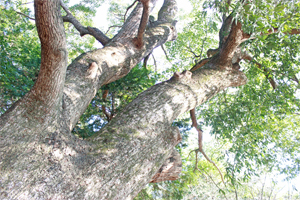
[60,0,110,46]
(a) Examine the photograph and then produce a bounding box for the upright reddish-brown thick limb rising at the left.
[32,0,67,108]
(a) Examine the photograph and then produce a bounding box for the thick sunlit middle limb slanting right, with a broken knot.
[64,0,176,129]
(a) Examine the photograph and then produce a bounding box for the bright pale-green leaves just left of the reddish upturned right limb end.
[164,2,219,74]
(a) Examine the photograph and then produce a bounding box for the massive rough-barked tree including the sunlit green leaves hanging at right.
[0,0,300,199]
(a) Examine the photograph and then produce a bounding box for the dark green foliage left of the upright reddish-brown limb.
[0,1,40,113]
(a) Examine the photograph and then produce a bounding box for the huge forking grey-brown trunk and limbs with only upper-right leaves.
[0,0,300,199]
